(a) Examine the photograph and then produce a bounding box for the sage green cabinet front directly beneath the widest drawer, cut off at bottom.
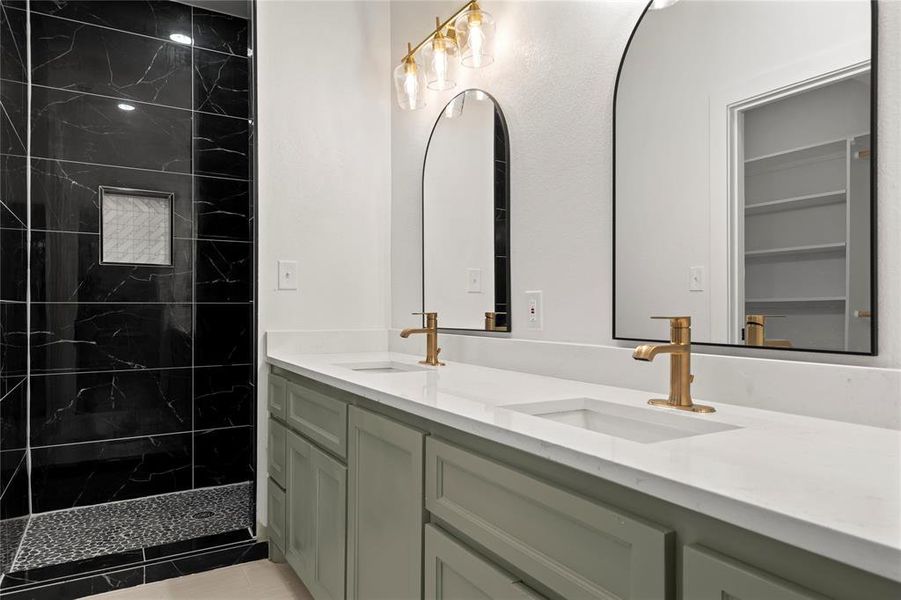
[423,525,539,600]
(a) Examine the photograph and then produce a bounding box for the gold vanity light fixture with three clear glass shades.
[394,0,495,110]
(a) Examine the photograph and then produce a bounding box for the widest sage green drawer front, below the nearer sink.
[426,438,673,600]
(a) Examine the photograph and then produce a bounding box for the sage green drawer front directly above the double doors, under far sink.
[285,381,347,458]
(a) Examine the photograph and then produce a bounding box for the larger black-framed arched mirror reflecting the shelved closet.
[614,0,876,354]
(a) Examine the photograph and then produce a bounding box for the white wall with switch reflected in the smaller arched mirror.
[423,94,495,329]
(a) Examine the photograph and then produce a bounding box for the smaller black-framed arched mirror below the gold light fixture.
[422,90,510,332]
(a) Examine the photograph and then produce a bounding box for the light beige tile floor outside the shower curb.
[90,560,313,600]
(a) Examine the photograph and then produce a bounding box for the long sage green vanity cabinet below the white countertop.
[268,367,901,600]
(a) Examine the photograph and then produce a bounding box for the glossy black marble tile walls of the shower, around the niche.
[0,0,256,548]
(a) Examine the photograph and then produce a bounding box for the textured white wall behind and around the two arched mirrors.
[391,0,901,368]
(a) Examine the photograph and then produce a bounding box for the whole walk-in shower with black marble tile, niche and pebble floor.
[0,0,266,599]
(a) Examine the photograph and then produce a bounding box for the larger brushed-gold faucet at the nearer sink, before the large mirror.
[632,317,716,413]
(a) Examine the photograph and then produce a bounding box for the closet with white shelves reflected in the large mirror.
[735,70,870,352]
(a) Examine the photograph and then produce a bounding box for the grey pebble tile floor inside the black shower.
[12,483,253,572]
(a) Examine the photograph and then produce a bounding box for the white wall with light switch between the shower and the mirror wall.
[256,0,392,523]
